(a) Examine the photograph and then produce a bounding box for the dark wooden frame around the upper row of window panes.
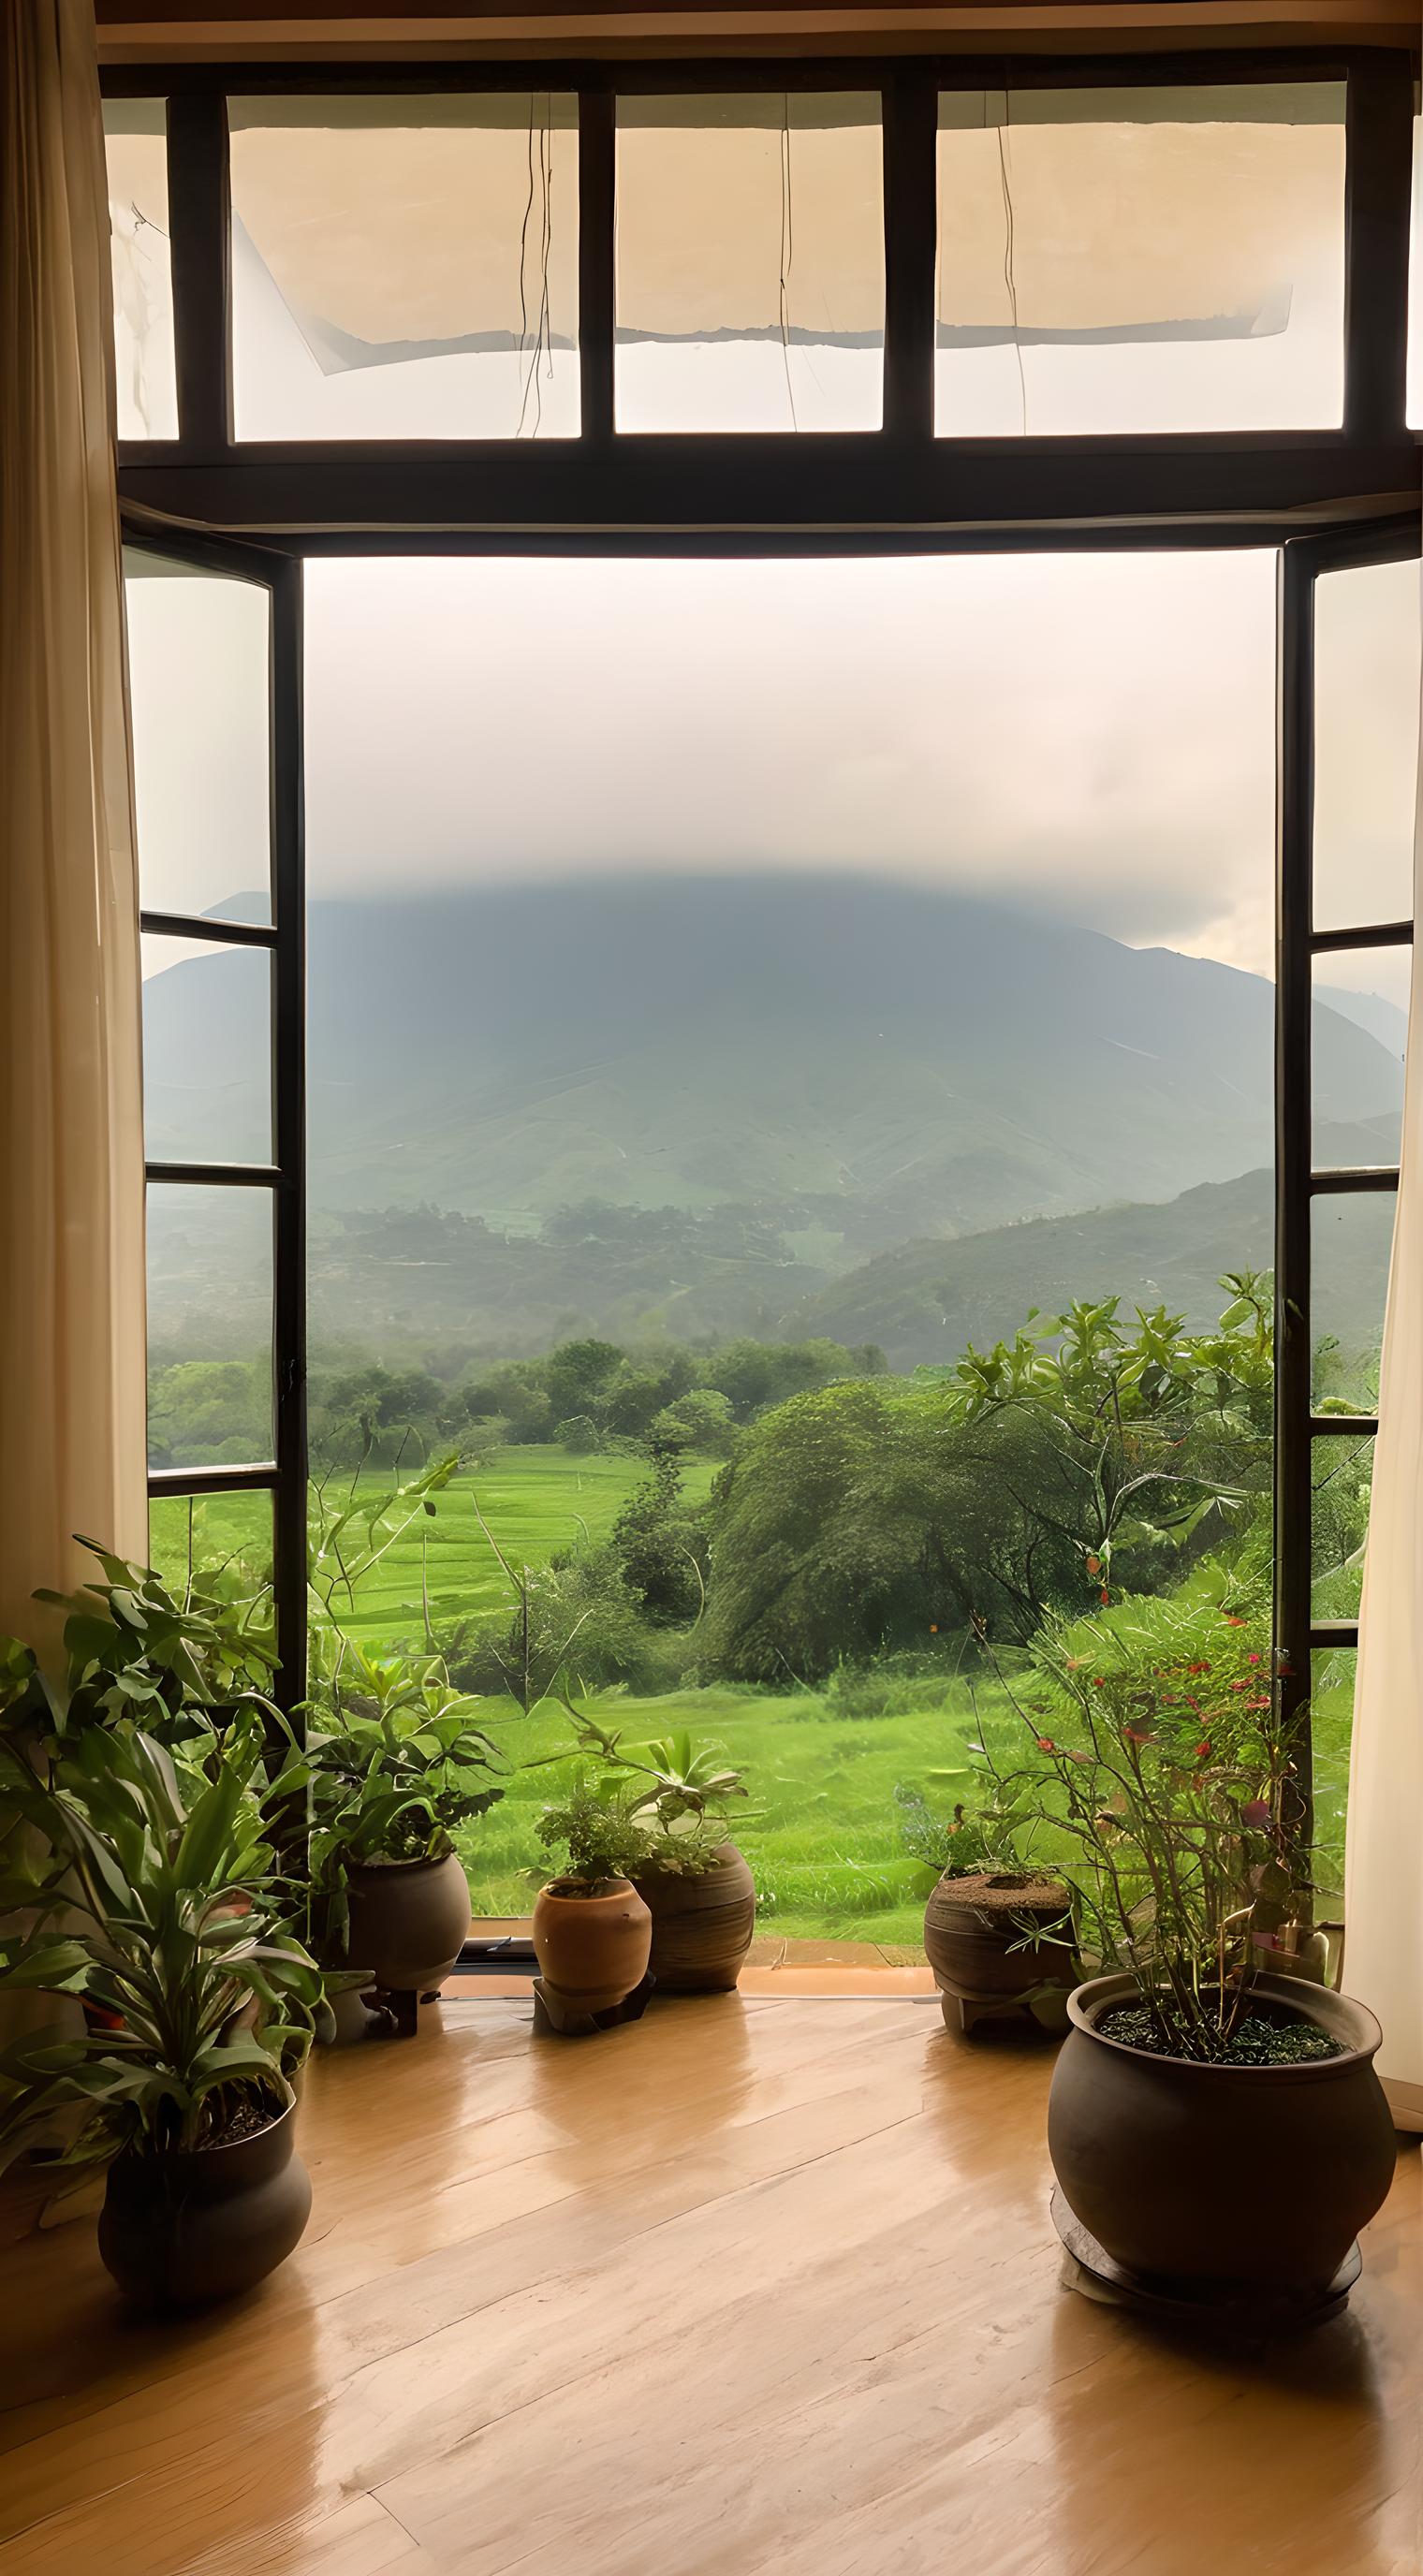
[103,47,1417,534]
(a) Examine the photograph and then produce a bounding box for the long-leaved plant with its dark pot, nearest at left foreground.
[0,1720,322,2308]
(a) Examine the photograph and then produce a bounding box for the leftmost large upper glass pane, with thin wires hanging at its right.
[227,90,578,438]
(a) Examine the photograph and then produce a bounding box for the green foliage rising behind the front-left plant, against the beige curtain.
[0,1538,276,1741]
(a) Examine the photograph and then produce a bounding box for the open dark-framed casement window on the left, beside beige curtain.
[124,535,307,1708]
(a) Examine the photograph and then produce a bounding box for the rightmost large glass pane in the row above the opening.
[936,82,1343,438]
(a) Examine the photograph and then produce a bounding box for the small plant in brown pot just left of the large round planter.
[897,1767,1078,2030]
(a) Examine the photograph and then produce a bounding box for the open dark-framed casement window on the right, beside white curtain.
[1276,520,1423,1885]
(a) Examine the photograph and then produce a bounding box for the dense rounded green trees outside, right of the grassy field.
[704,1275,1271,1682]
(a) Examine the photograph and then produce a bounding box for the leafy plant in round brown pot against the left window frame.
[288,1638,503,1994]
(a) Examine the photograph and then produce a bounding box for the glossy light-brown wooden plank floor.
[0,1997,1423,2576]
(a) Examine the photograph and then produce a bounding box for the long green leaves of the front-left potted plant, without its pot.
[0,1716,322,2164]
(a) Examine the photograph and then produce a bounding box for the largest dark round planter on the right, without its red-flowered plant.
[1047,1976,1395,2298]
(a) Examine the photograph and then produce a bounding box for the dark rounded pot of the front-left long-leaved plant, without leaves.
[98,2102,312,2308]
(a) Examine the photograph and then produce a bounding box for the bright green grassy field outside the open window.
[152,1448,1354,1948]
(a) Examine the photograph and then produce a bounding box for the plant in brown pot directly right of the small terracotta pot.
[556,1713,756,1994]
